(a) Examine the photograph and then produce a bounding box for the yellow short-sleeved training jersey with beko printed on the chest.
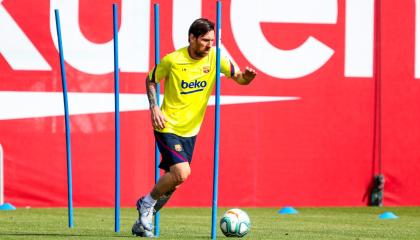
[149,47,239,137]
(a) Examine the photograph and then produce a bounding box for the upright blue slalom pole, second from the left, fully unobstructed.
[112,3,120,232]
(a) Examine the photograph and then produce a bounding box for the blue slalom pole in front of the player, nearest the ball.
[211,1,222,239]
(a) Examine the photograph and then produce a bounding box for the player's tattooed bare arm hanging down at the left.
[146,76,166,130]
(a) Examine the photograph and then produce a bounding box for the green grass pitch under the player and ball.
[0,207,420,240]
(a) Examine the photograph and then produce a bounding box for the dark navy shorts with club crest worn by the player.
[154,131,196,172]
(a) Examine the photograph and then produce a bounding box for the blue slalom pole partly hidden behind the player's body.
[154,3,160,237]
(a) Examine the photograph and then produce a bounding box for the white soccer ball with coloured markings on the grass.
[220,208,251,237]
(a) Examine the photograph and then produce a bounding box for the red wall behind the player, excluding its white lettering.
[0,0,420,207]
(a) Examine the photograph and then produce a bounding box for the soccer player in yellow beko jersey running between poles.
[132,18,256,237]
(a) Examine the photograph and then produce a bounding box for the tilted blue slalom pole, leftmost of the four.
[54,9,74,228]
